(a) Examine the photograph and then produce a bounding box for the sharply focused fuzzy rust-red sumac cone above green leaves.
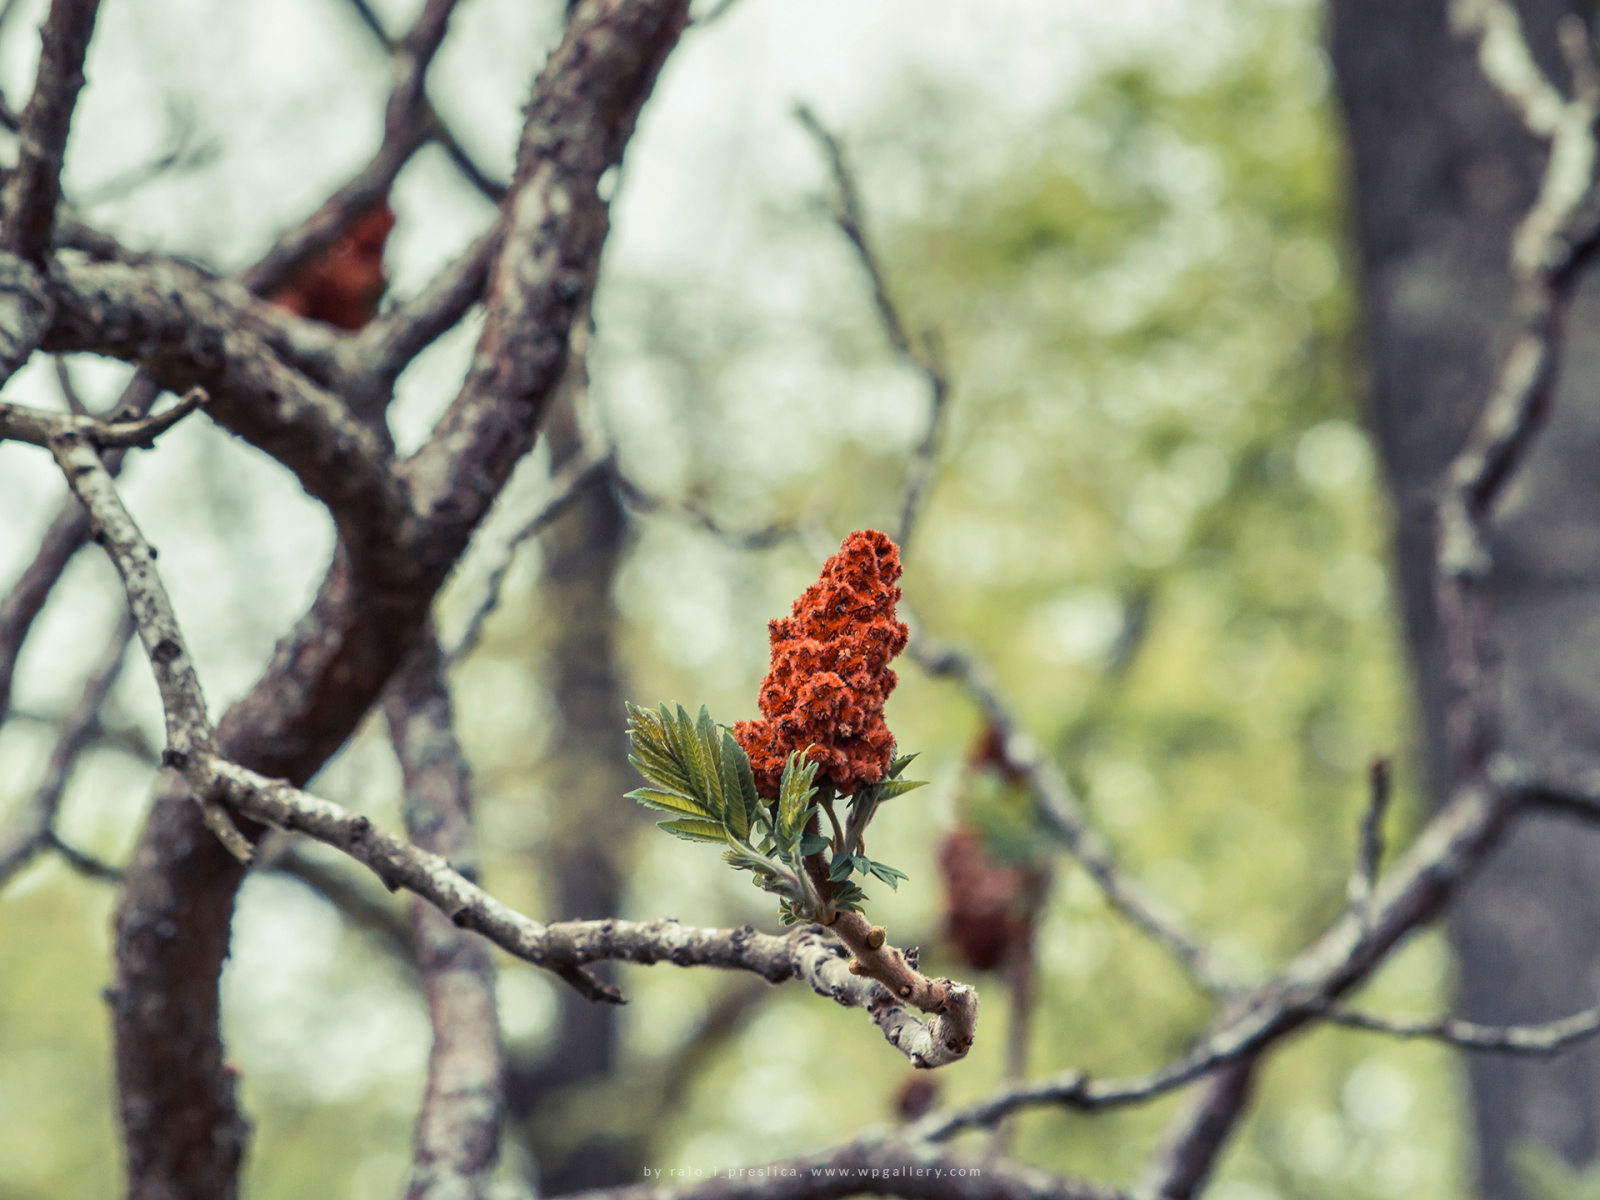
[733,530,907,798]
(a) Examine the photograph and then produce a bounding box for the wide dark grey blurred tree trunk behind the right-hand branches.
[1330,0,1600,1200]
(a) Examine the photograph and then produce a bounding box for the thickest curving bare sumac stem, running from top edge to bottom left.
[101,0,683,1200]
